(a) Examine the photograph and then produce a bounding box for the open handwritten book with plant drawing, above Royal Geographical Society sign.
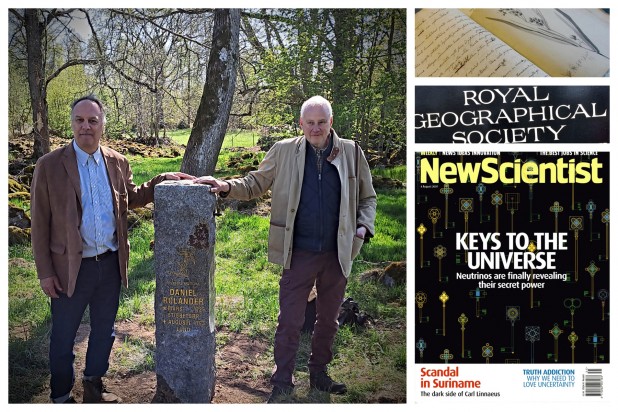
[416,9,609,77]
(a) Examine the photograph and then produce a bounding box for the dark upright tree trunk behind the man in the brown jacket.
[24,9,50,159]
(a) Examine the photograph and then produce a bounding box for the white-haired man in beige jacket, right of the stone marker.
[196,96,376,402]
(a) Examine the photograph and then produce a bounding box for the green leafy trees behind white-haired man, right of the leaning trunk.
[242,9,406,158]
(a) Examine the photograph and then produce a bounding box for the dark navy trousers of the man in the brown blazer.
[49,253,120,399]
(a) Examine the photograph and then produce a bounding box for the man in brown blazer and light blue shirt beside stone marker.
[31,96,193,403]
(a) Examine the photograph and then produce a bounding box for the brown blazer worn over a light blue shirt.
[30,143,165,297]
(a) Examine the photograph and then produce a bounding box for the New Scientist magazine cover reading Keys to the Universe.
[414,151,611,402]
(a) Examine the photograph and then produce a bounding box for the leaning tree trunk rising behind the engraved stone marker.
[180,9,240,176]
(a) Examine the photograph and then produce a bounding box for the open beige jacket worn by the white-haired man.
[227,129,376,277]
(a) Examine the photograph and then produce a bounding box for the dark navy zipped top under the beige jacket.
[294,136,341,252]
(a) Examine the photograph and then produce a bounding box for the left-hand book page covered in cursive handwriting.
[415,9,547,77]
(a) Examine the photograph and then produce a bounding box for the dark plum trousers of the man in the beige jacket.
[270,250,347,386]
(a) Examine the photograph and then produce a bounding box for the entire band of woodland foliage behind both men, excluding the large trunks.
[9,8,407,165]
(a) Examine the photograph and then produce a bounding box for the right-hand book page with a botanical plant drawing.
[470,9,609,77]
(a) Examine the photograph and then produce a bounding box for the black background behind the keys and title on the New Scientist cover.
[413,152,611,363]
